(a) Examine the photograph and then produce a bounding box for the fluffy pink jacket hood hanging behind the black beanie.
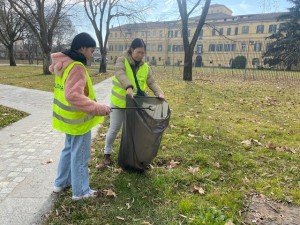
[49,52,74,76]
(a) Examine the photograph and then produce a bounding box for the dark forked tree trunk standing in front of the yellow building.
[177,0,211,81]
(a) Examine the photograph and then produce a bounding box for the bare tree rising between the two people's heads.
[84,0,152,73]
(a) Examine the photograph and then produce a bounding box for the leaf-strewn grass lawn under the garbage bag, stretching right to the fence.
[44,68,300,225]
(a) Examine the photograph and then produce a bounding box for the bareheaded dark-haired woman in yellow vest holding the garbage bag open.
[101,38,165,167]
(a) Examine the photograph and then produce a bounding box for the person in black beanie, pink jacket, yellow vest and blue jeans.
[49,33,111,200]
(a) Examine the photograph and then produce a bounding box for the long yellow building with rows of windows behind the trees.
[107,4,284,68]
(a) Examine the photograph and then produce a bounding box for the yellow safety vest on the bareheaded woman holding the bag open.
[110,58,149,108]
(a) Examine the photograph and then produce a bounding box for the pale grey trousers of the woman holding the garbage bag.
[104,103,125,154]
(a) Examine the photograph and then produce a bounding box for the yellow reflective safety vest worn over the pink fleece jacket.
[52,62,104,135]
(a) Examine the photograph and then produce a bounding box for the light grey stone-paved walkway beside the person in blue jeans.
[0,78,111,225]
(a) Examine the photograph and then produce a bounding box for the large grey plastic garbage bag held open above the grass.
[118,96,171,171]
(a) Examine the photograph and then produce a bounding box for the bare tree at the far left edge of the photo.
[0,1,25,66]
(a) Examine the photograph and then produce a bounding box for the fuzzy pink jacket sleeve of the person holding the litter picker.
[65,65,105,116]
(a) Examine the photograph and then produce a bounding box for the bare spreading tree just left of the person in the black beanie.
[8,0,74,74]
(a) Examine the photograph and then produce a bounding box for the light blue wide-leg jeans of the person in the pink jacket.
[54,131,91,196]
